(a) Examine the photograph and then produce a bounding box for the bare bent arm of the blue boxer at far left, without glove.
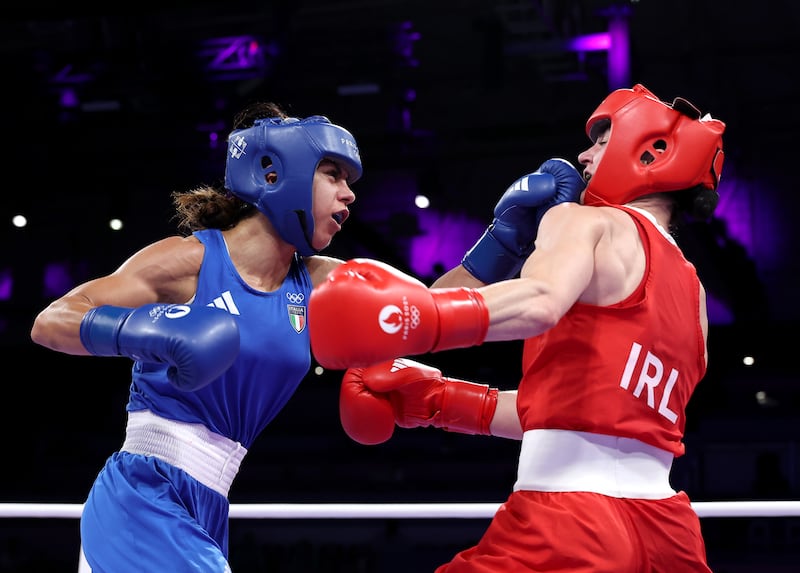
[31,233,203,355]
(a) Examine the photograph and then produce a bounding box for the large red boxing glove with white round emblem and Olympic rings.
[308,259,489,370]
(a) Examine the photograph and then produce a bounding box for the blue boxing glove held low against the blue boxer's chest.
[80,304,239,392]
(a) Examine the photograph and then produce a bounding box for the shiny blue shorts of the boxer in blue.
[81,452,230,573]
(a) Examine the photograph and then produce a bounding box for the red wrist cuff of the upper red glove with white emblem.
[431,287,489,352]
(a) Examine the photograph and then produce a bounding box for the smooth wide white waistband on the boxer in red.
[514,430,675,499]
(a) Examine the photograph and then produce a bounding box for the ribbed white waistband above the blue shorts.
[121,410,247,497]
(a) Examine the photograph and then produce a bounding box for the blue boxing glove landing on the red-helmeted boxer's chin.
[461,159,586,284]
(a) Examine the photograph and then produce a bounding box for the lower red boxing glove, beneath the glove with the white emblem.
[339,358,498,445]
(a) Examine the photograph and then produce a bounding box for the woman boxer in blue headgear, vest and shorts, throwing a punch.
[31,103,583,573]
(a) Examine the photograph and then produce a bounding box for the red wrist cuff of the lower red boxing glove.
[436,378,498,436]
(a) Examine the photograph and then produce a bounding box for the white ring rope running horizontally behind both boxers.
[0,501,800,519]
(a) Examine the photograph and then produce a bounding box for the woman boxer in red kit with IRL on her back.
[309,85,725,573]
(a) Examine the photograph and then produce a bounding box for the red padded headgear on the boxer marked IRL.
[584,84,725,205]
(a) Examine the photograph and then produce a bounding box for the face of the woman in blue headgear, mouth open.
[311,159,356,251]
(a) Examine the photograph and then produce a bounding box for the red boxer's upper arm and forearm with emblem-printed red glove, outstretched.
[309,203,604,369]
